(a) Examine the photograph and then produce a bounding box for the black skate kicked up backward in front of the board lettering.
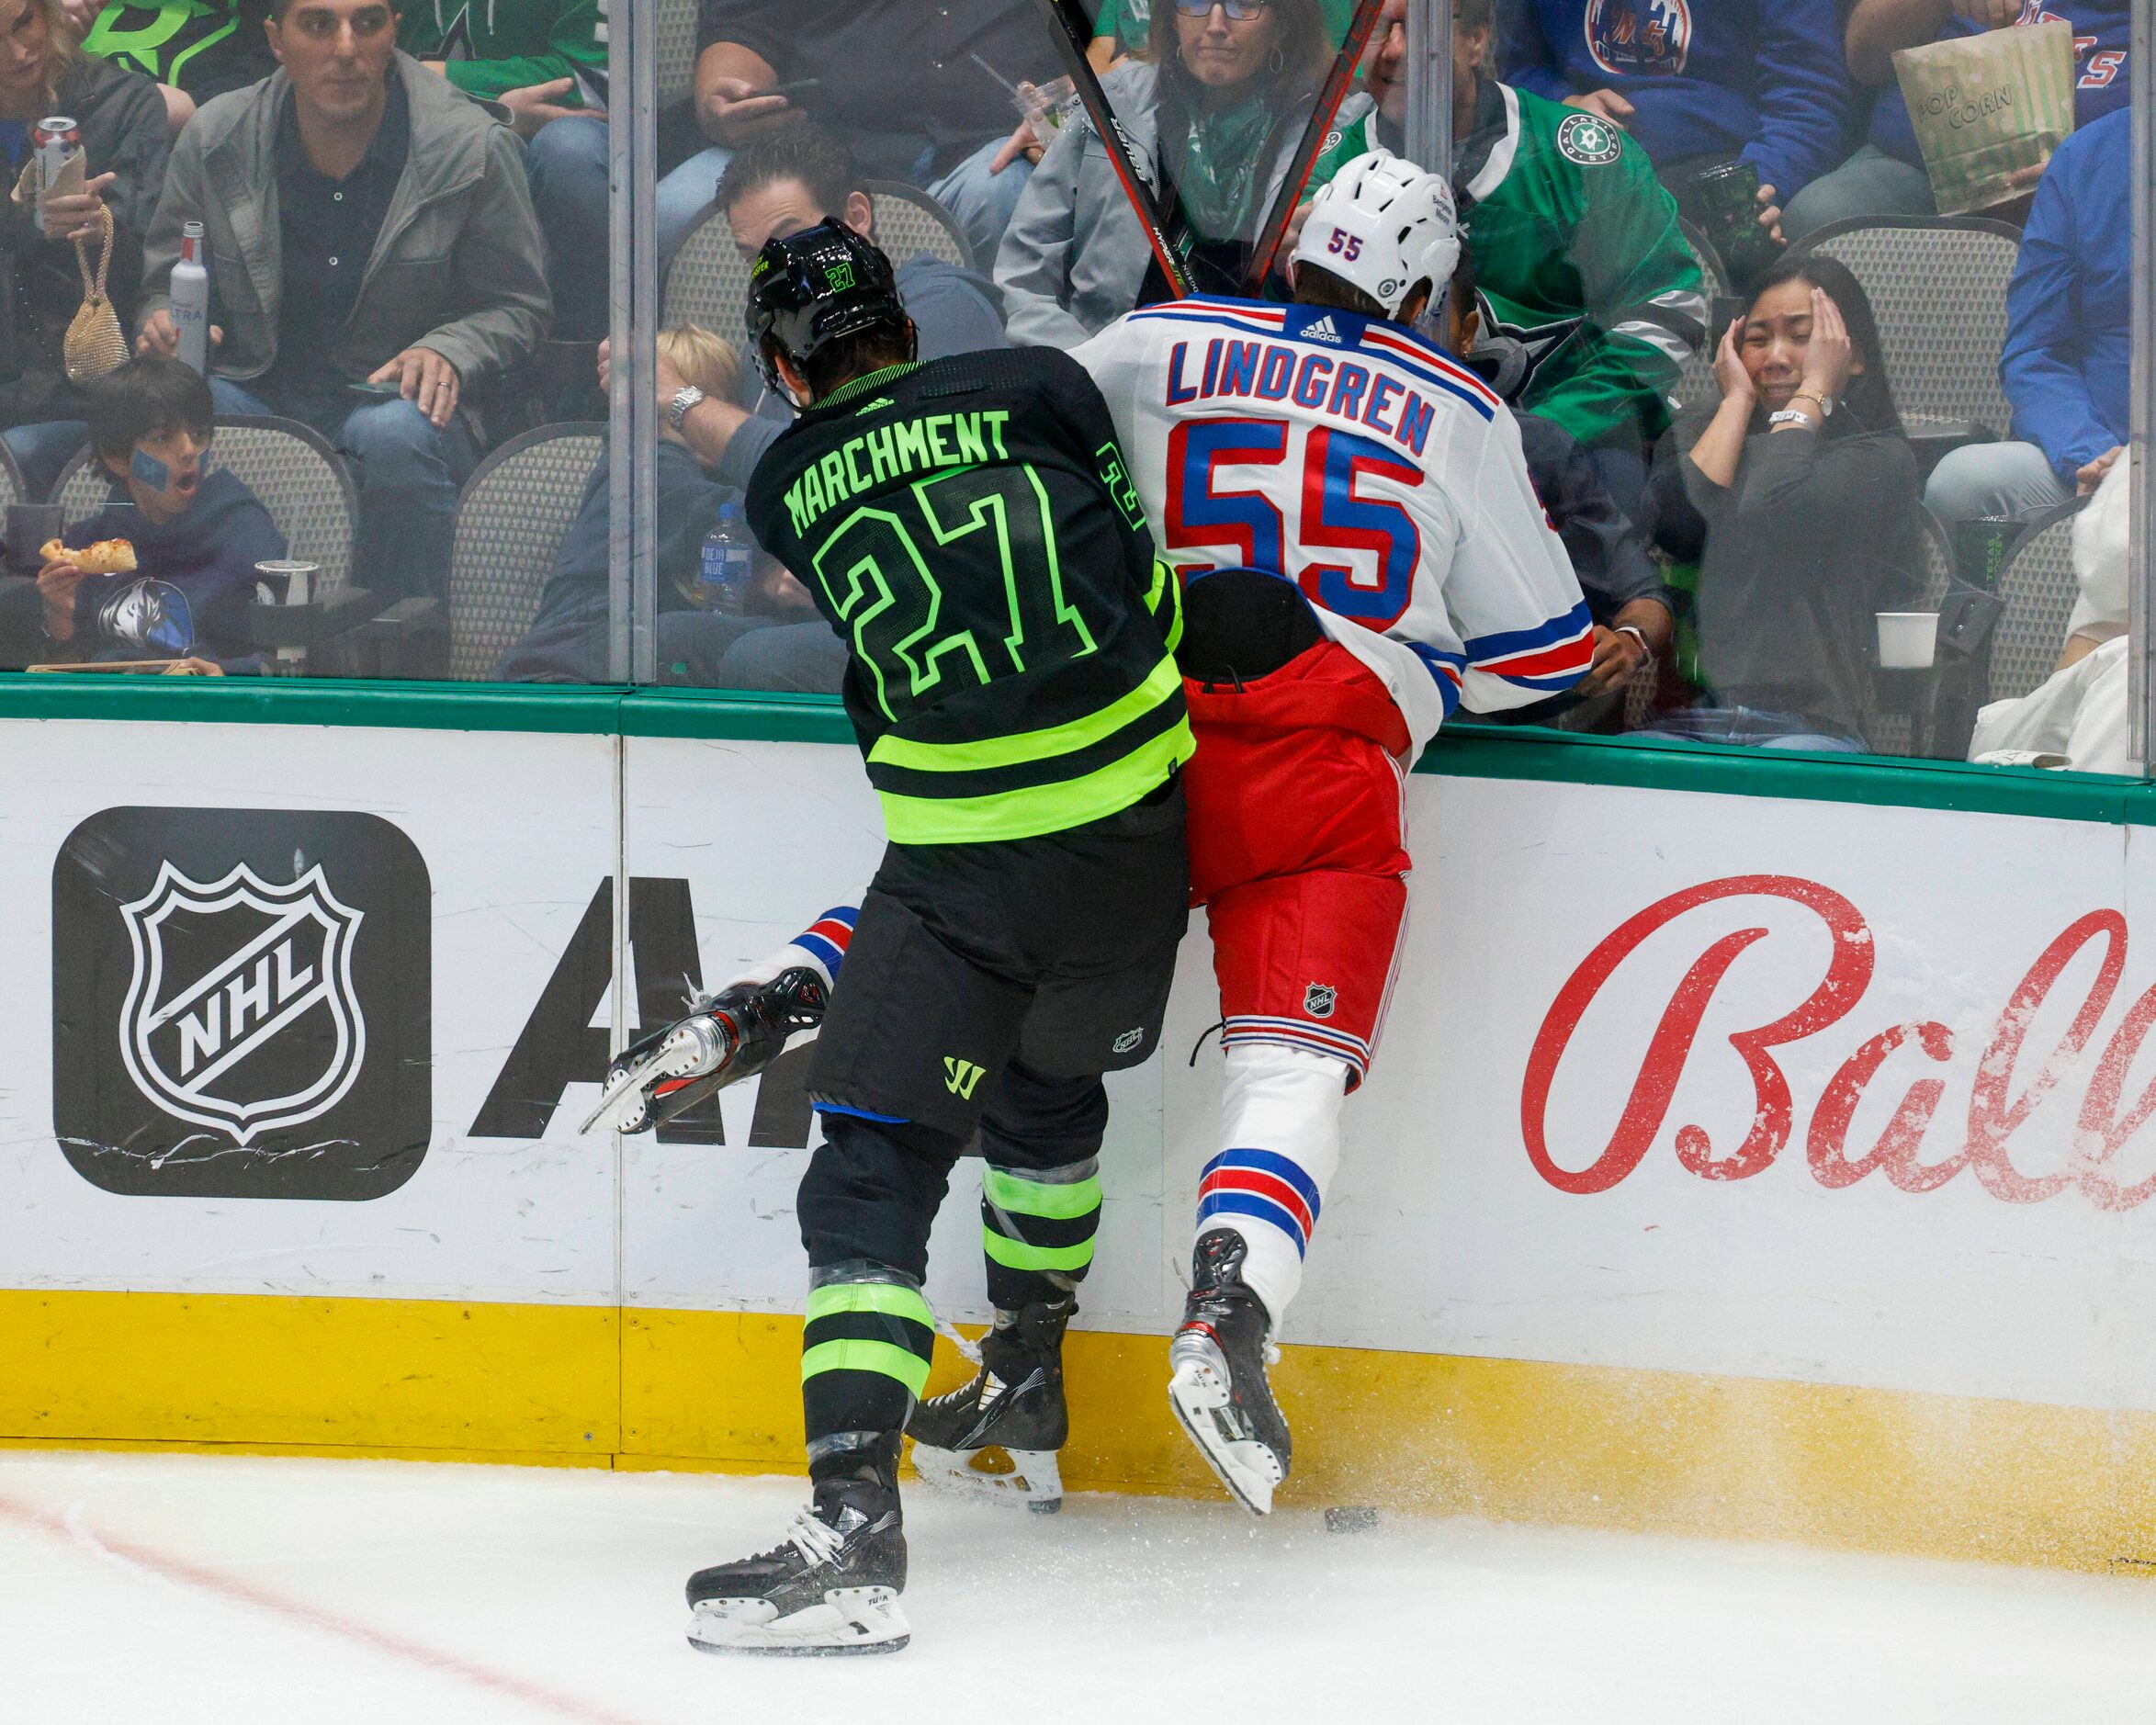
[584,968,830,1134]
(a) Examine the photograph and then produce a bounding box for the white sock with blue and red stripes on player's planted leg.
[1199,1042,1348,1330]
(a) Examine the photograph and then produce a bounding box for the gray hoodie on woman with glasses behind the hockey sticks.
[996,61,1369,347]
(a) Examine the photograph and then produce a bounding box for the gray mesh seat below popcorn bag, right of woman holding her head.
[1796,218,2020,440]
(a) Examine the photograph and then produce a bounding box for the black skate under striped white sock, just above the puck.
[1168,1229,1290,1516]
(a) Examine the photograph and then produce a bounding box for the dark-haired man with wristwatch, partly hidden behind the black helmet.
[660,125,1009,491]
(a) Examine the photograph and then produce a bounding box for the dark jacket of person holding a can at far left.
[0,58,173,424]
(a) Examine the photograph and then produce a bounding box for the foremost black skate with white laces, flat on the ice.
[688,1479,912,1654]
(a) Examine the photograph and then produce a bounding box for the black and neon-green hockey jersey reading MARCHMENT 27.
[748,347,1194,845]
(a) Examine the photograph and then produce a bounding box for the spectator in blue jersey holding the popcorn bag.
[1781,0,2132,242]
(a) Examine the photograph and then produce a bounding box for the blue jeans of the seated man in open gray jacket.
[209,378,479,603]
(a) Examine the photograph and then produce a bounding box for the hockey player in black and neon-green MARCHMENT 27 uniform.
[672,222,1192,1652]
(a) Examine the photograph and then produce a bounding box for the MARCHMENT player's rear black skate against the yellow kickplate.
[906,1301,1078,1516]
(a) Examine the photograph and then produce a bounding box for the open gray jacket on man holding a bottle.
[142,54,554,389]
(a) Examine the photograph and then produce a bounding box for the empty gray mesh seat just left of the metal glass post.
[448,421,606,683]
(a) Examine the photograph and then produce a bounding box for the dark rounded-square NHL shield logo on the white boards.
[51,808,434,1199]
